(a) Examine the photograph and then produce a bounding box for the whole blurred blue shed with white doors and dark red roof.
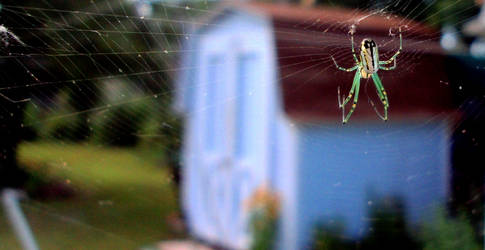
[175,3,453,249]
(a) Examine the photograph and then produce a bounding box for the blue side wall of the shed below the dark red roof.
[297,123,449,247]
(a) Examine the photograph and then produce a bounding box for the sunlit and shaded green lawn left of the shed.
[0,143,183,249]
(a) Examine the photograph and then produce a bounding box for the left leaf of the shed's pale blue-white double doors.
[201,51,232,241]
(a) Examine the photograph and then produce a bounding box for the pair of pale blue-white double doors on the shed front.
[201,50,266,248]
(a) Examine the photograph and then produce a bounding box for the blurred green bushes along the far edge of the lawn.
[23,81,182,148]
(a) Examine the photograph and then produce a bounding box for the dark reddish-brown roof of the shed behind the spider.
[223,3,452,122]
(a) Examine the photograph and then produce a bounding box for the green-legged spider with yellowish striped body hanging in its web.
[332,28,402,124]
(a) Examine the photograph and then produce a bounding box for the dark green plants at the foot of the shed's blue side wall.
[313,199,481,250]
